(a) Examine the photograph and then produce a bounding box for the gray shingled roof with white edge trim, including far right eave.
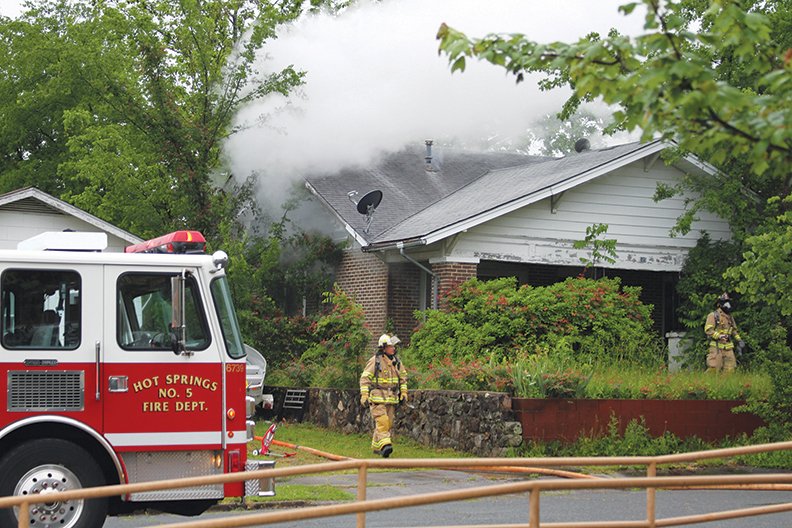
[308,140,715,249]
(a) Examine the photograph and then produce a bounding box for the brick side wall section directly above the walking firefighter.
[336,249,388,346]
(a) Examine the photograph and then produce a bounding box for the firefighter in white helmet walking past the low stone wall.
[360,334,407,458]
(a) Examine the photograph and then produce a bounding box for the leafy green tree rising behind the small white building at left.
[0,0,346,236]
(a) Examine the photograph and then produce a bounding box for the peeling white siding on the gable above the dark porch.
[449,162,730,271]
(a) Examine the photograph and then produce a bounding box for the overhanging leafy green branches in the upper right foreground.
[438,0,792,182]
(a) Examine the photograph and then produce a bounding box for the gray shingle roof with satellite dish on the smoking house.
[306,142,658,249]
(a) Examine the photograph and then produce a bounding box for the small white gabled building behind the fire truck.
[0,187,143,252]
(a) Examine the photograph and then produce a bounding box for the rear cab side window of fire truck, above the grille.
[0,269,82,350]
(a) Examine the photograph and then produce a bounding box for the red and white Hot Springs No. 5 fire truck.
[0,231,271,528]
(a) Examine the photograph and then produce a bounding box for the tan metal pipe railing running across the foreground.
[0,441,792,528]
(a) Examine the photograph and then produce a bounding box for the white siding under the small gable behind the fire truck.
[0,208,129,252]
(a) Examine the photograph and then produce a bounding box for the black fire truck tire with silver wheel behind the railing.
[0,439,108,528]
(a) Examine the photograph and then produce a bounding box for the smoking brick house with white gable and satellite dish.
[306,141,731,336]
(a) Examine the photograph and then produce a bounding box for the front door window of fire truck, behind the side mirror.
[116,273,210,350]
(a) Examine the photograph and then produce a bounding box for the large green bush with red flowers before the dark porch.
[405,277,664,366]
